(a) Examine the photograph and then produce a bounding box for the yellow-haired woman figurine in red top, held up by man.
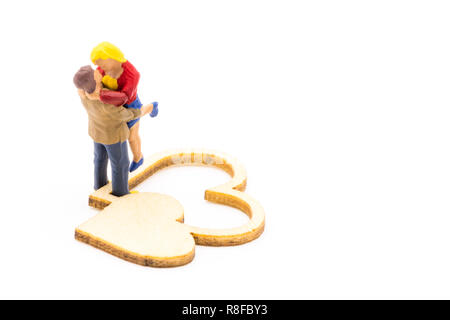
[91,42,158,172]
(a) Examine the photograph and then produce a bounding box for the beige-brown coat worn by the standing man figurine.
[81,98,141,144]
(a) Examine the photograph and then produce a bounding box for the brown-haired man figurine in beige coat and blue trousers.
[73,66,153,197]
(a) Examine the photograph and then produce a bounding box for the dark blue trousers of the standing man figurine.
[94,141,130,197]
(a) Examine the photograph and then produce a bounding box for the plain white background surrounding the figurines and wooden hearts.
[0,0,450,299]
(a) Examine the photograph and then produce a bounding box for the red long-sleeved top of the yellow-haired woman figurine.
[97,61,140,106]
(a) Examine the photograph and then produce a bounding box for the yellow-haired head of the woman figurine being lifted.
[91,42,127,72]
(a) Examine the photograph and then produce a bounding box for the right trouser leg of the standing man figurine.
[105,141,130,197]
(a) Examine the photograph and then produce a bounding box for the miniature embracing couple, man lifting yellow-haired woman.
[73,42,158,196]
